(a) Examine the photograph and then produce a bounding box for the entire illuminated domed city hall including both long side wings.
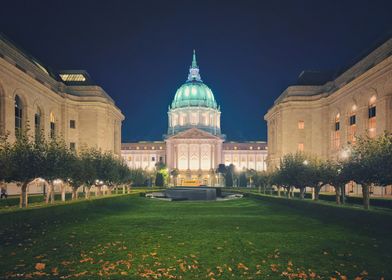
[121,53,267,185]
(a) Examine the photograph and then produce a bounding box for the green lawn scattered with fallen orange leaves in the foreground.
[0,194,392,279]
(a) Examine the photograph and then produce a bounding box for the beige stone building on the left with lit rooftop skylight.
[0,36,124,155]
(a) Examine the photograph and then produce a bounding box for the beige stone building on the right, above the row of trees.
[264,39,392,169]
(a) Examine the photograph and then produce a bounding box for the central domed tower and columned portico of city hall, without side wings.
[165,51,225,185]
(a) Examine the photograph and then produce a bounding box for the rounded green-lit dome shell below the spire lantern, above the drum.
[171,81,218,109]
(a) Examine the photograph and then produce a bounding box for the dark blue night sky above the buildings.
[0,0,392,141]
